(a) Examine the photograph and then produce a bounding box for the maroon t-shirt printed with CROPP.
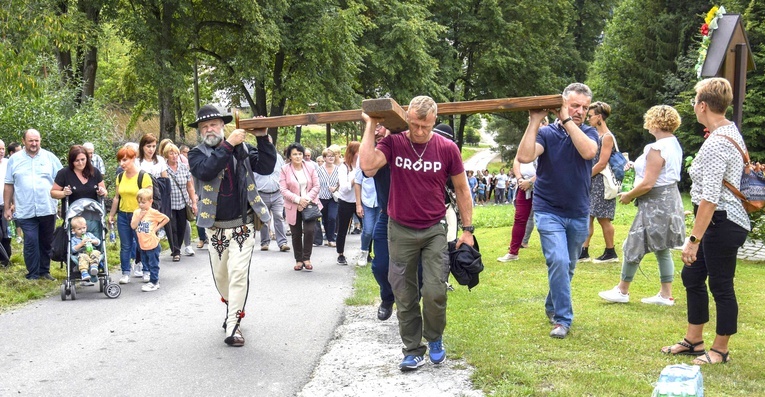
[377,131,465,229]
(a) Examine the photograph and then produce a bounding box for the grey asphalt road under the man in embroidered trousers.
[0,230,359,396]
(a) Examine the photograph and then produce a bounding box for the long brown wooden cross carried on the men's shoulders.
[238,95,563,132]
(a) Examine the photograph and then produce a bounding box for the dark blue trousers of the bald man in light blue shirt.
[16,215,56,280]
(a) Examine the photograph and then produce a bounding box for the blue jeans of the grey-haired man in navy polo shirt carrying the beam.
[534,211,589,328]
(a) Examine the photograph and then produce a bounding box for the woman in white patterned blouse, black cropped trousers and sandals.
[662,78,750,364]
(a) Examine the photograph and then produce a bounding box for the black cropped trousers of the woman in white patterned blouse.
[681,211,748,335]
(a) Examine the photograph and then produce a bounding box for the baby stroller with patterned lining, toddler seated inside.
[61,198,122,301]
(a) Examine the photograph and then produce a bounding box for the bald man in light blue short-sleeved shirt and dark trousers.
[3,128,61,280]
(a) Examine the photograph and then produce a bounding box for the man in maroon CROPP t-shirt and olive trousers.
[359,96,474,371]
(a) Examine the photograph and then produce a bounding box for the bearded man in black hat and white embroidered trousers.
[189,105,276,347]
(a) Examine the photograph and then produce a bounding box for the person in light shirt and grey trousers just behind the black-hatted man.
[253,135,290,252]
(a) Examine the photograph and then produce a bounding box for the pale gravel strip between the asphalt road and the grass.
[297,306,484,397]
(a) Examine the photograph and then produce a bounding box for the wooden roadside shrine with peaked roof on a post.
[701,14,755,129]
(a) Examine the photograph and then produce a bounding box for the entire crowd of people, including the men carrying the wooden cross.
[0,78,762,371]
